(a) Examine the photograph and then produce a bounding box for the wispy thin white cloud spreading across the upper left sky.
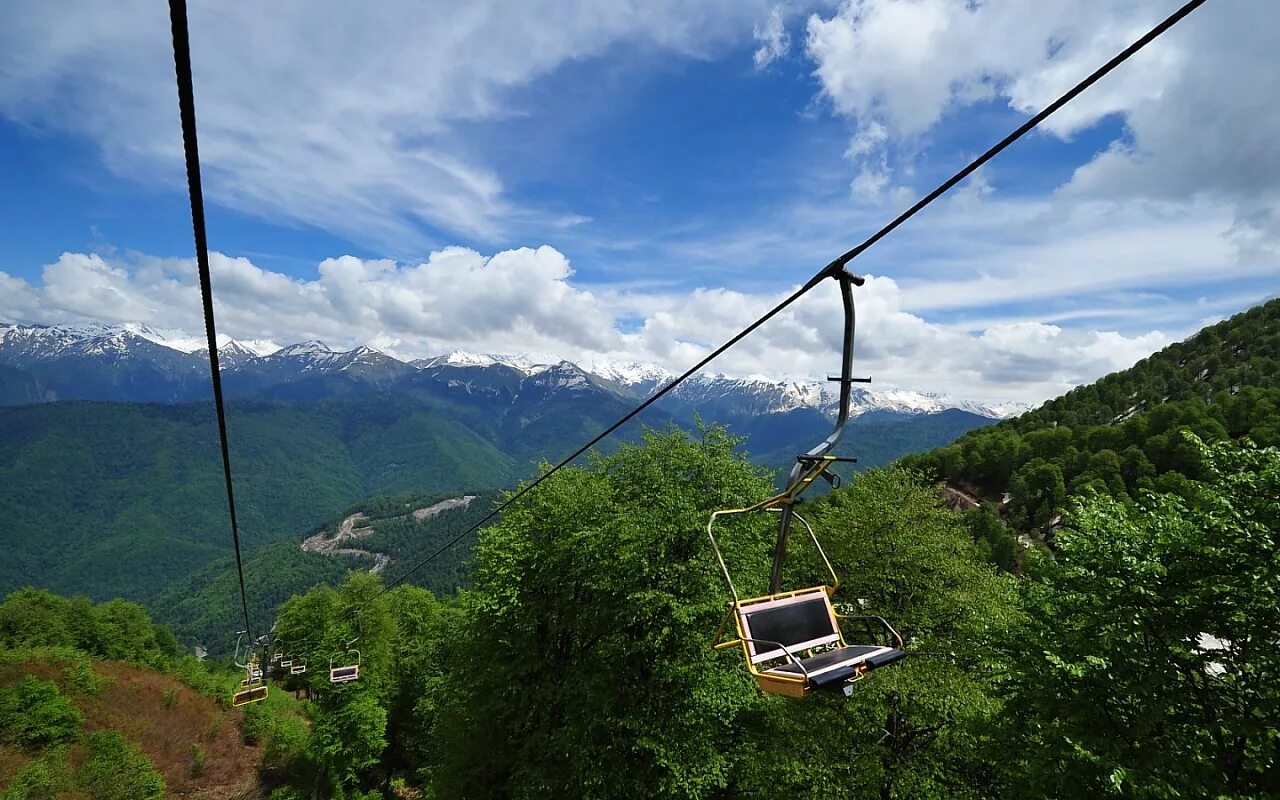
[0,0,767,253]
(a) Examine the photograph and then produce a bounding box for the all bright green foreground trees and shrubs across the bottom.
[0,429,1280,800]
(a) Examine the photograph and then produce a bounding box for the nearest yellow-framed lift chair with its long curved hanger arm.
[707,265,906,698]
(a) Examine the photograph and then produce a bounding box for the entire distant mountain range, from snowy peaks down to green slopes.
[0,318,1012,602]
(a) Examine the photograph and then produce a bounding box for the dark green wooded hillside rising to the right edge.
[904,300,1280,527]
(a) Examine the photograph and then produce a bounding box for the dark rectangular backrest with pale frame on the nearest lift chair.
[737,586,840,664]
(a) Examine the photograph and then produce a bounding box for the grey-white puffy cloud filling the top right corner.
[805,0,1280,239]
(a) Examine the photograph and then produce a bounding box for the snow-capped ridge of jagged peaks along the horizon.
[0,323,1025,419]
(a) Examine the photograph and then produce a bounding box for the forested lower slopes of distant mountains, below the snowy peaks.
[0,383,991,604]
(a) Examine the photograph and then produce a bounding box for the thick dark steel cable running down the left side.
[169,0,255,641]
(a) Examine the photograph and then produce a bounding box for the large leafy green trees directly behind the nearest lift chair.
[249,429,1019,797]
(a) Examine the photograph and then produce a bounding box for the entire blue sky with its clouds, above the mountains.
[0,0,1280,401]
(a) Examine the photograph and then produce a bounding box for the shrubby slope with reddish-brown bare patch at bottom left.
[0,590,270,800]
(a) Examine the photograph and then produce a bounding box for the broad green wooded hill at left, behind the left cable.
[0,396,524,600]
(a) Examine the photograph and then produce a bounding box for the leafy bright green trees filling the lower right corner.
[1004,438,1280,797]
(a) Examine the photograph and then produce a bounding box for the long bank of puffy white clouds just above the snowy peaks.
[0,246,1167,401]
